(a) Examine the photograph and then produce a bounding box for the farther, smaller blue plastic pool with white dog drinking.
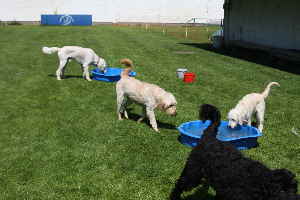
[91,67,136,82]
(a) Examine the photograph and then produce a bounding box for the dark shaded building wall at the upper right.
[224,0,300,51]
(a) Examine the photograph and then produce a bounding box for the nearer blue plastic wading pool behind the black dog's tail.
[177,120,262,150]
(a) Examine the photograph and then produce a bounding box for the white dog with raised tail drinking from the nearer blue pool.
[227,82,280,131]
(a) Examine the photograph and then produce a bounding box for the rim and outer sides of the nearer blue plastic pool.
[177,120,262,150]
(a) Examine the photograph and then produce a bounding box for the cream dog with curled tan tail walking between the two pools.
[116,59,177,132]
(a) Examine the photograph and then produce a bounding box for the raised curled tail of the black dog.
[199,104,221,137]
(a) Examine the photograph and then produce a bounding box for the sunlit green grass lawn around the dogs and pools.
[0,26,300,200]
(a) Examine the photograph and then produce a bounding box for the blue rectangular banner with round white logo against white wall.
[41,15,93,26]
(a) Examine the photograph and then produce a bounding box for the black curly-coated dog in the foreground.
[170,104,300,200]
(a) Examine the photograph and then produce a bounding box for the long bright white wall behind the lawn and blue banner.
[0,0,224,23]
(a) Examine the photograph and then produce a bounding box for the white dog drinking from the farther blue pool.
[42,46,107,81]
